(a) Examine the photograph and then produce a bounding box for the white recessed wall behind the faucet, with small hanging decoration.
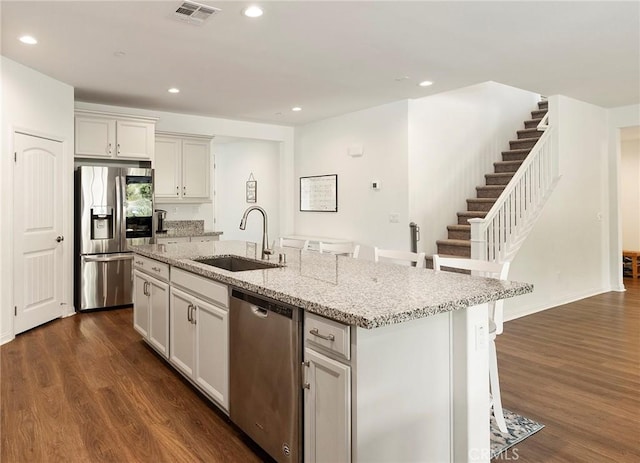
[214,141,281,246]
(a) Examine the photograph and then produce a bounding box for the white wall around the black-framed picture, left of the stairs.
[293,101,409,258]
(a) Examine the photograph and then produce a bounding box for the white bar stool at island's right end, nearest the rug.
[433,254,510,433]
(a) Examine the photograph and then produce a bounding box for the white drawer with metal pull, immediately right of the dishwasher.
[304,313,351,360]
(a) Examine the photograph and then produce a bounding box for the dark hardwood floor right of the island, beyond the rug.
[496,278,640,463]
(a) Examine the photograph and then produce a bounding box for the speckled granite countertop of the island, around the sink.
[133,241,533,329]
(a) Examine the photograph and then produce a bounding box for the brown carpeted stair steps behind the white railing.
[436,101,548,260]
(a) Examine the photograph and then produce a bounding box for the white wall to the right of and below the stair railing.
[505,96,611,320]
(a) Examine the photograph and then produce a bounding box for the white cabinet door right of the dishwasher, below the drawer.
[304,348,351,463]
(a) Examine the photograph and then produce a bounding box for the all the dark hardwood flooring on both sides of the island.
[0,279,640,463]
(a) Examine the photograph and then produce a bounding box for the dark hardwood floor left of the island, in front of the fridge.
[0,309,268,463]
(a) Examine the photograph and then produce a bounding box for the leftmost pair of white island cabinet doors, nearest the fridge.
[133,269,169,357]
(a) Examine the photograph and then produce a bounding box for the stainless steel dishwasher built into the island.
[229,289,302,462]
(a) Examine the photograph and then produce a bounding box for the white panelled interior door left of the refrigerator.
[13,133,63,334]
